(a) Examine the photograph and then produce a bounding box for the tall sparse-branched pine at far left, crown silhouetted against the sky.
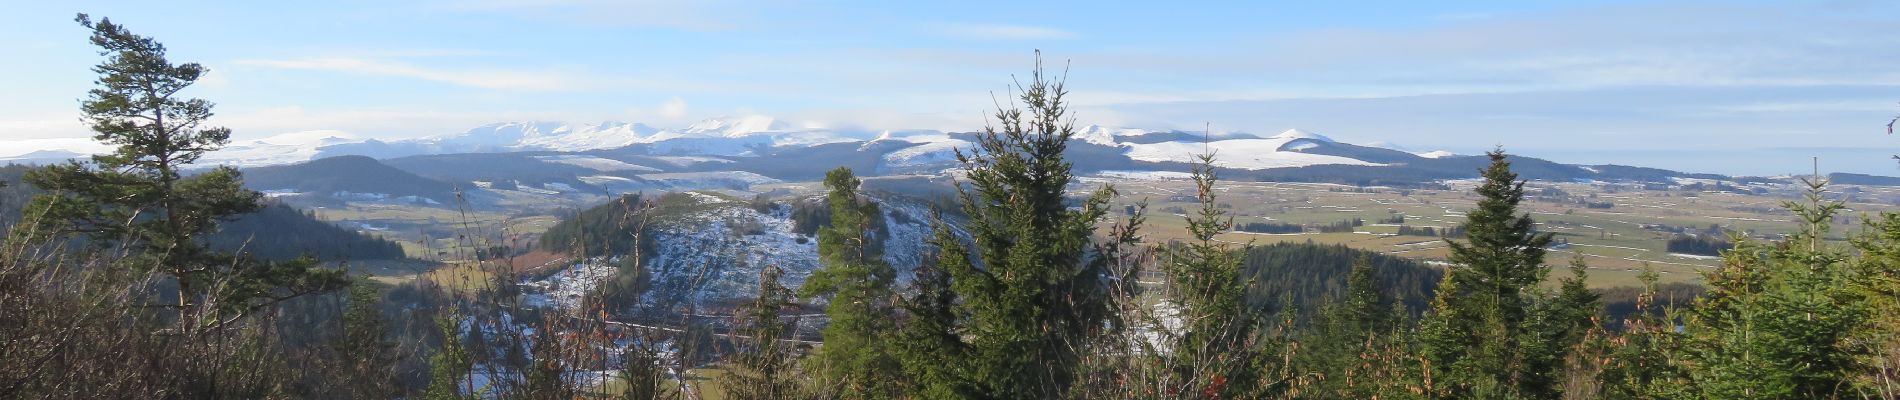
[14,13,350,332]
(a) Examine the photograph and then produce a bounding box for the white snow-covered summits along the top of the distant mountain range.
[155,116,1448,169]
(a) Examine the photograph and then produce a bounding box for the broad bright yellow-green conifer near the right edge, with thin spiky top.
[1683,180,1875,398]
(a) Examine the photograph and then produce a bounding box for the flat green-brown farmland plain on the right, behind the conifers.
[1075,180,1896,286]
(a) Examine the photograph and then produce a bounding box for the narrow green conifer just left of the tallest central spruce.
[798,167,899,398]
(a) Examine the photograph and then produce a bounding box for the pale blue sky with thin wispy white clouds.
[0,0,1900,176]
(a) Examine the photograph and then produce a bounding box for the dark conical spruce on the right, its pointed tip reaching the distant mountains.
[1425,150,1558,398]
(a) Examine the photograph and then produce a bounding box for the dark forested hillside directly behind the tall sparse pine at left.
[0,165,403,262]
